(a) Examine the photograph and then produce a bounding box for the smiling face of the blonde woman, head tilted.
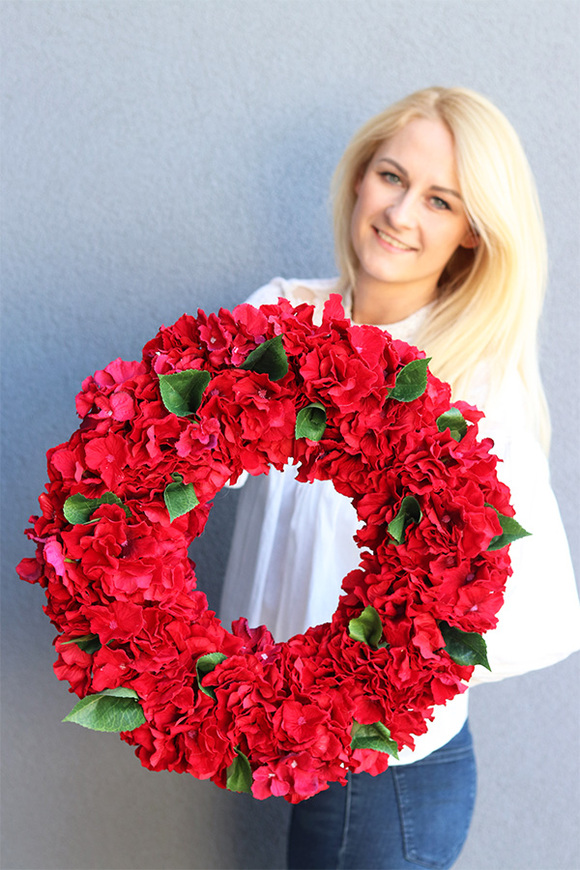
[351,118,477,309]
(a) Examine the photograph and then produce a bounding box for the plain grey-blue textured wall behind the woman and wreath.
[0,0,580,870]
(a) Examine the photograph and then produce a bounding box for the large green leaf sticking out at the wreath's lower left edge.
[62,686,146,732]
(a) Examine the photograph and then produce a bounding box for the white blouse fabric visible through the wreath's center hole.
[214,466,360,642]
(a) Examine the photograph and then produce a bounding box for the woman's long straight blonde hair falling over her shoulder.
[333,87,550,449]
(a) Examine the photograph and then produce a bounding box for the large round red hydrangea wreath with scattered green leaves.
[18,296,526,803]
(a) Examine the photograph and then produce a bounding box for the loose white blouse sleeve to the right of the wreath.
[470,375,580,685]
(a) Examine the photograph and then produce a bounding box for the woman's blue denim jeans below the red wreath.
[288,723,476,870]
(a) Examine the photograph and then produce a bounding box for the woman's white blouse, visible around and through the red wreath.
[220,278,580,764]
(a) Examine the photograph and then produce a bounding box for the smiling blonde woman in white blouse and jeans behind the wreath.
[222,88,580,870]
